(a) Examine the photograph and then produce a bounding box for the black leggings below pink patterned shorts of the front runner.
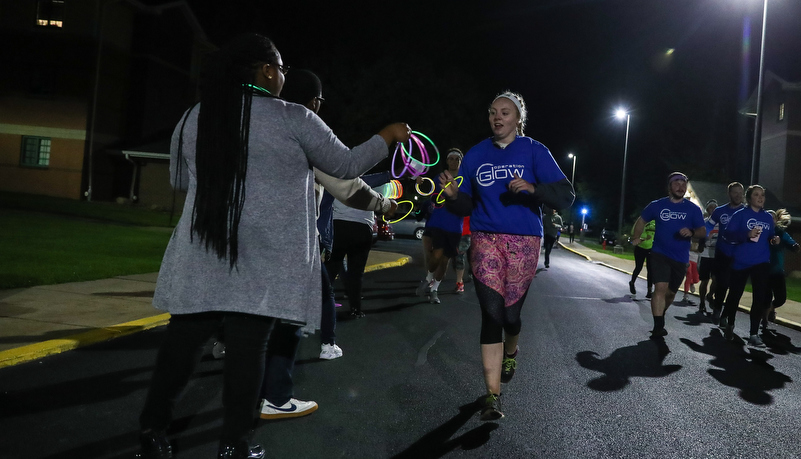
[473,277,528,344]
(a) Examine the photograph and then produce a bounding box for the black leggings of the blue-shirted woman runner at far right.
[715,263,770,335]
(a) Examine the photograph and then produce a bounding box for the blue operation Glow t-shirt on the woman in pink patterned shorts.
[459,136,566,237]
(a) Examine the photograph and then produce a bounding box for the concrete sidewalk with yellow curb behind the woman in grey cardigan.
[0,250,411,368]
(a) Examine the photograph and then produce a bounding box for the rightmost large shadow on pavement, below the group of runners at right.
[680,329,792,405]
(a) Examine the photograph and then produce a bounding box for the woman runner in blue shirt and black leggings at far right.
[718,185,780,347]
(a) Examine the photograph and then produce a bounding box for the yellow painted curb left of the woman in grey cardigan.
[0,314,170,368]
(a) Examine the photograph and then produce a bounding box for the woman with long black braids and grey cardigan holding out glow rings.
[138,34,411,459]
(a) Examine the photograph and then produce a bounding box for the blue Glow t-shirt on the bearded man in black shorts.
[640,197,704,263]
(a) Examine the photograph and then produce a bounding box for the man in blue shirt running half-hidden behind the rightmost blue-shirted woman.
[706,182,745,328]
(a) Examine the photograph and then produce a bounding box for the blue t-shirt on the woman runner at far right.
[718,207,776,270]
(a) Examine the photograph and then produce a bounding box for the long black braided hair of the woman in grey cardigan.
[190,34,278,270]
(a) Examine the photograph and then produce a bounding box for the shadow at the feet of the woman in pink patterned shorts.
[393,396,498,459]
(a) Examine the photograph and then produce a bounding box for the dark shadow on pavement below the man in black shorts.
[576,339,681,392]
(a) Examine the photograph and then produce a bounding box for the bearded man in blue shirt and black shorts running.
[631,172,706,338]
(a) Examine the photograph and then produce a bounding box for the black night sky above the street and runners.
[172,0,801,230]
